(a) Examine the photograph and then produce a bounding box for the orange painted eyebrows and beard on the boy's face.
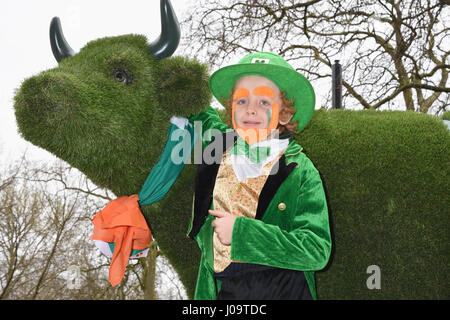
[231,86,279,145]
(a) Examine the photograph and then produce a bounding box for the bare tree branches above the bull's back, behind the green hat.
[183,0,450,114]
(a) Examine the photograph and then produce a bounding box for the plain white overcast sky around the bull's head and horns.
[0,0,197,169]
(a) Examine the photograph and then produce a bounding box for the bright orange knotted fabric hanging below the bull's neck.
[91,194,152,287]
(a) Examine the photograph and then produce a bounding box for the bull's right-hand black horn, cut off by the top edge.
[149,0,181,60]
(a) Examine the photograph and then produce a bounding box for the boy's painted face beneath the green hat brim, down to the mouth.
[233,75,281,129]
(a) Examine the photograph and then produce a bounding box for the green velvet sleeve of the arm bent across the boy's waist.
[231,161,331,271]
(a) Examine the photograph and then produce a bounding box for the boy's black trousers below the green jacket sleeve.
[216,266,312,300]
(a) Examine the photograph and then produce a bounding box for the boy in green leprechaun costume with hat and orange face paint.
[188,52,331,299]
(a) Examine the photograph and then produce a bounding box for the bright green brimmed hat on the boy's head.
[209,52,316,131]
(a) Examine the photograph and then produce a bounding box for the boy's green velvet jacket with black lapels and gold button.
[188,108,331,300]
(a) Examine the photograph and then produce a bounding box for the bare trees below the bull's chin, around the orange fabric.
[0,157,185,299]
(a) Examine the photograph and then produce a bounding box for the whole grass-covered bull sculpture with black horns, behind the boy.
[15,1,450,299]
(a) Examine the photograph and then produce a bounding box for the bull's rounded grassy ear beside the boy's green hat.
[158,57,212,117]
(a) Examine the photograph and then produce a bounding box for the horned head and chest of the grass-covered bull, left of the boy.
[15,1,211,293]
